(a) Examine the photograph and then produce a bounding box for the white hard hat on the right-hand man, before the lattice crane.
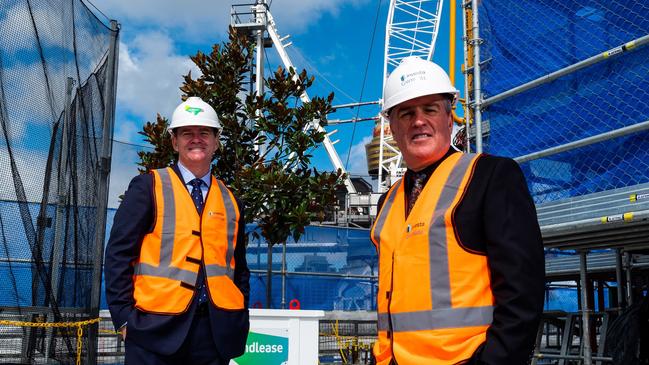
[381,56,460,113]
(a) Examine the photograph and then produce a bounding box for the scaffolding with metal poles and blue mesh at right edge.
[464,0,649,365]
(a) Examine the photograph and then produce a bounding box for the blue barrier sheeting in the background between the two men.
[246,226,378,311]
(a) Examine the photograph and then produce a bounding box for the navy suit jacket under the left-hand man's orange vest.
[104,166,250,359]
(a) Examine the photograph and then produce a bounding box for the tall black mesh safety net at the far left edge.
[0,0,116,363]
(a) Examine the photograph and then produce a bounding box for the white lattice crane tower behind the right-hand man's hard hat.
[378,0,444,193]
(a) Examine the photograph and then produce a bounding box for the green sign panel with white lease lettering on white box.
[230,329,288,365]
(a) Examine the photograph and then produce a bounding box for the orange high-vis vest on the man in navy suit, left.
[133,168,244,314]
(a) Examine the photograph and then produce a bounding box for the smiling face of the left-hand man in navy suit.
[171,126,219,167]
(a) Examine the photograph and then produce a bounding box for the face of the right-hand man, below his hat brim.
[389,94,453,171]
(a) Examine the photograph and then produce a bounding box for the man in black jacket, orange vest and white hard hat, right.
[371,57,544,365]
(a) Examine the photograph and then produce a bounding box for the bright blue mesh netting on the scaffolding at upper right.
[470,0,649,204]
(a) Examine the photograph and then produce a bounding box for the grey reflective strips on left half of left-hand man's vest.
[135,168,198,285]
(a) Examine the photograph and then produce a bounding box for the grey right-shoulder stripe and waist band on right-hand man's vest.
[379,154,493,332]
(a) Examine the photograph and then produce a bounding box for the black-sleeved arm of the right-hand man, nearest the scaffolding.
[476,158,545,365]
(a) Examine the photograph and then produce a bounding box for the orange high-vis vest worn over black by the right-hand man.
[371,153,494,365]
